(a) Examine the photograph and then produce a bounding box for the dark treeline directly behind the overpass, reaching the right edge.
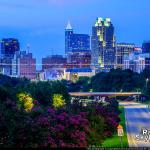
[69,69,150,97]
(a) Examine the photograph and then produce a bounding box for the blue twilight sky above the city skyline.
[0,0,150,67]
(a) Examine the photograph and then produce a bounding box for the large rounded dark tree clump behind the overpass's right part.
[91,69,143,92]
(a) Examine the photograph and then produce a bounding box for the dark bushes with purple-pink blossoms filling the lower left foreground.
[0,97,89,148]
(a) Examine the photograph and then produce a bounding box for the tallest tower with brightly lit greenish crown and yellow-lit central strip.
[91,18,115,71]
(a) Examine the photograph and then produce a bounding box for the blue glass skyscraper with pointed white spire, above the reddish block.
[65,23,90,55]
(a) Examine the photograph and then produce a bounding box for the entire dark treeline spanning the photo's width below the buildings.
[0,69,150,101]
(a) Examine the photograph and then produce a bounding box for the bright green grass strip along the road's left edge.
[102,106,128,148]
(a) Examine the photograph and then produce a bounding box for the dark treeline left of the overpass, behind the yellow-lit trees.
[0,75,70,106]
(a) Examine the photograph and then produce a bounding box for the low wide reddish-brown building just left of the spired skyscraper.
[42,55,67,71]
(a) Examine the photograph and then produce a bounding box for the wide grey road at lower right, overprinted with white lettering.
[120,102,150,148]
